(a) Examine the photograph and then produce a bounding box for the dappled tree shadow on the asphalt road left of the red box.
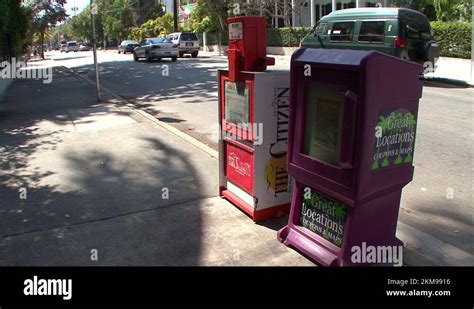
[74,57,227,108]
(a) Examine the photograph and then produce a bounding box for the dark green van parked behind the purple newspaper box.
[300,8,440,70]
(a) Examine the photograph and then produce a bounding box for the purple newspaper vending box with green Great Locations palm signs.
[278,48,423,266]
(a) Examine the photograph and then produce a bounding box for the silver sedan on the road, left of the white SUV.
[133,38,179,62]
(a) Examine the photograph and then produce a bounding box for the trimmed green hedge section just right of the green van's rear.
[431,21,472,59]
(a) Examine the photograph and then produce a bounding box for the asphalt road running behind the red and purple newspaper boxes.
[46,51,474,254]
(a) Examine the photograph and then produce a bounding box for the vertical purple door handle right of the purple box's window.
[339,90,357,169]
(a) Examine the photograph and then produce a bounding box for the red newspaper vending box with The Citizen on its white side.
[218,16,291,221]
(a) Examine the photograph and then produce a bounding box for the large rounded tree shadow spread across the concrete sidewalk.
[0,69,210,266]
